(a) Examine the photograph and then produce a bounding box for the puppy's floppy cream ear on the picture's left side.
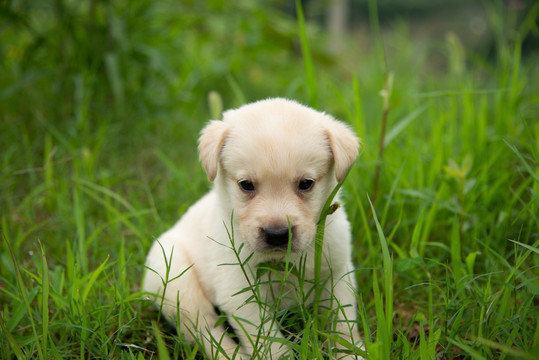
[198,120,228,181]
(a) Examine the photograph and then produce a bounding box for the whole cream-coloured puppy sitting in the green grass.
[144,98,361,359]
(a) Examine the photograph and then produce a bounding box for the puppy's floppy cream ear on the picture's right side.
[326,118,360,183]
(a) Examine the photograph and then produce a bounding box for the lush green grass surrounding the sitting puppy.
[0,0,539,359]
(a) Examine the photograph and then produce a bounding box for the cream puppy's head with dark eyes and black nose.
[199,99,359,254]
